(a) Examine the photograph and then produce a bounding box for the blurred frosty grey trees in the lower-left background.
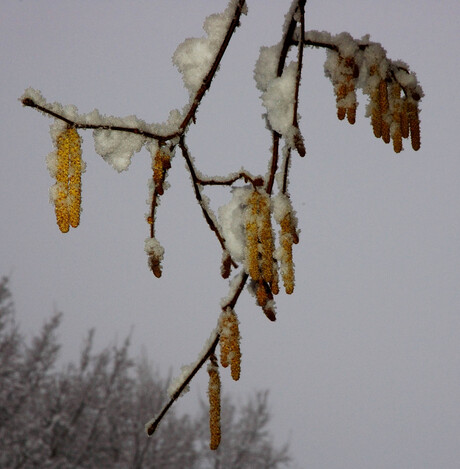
[0,278,289,469]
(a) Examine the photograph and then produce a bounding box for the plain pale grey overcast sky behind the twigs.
[0,0,460,469]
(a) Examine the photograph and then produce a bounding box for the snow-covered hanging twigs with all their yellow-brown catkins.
[21,0,423,449]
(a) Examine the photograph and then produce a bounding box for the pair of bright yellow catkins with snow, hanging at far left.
[47,127,84,233]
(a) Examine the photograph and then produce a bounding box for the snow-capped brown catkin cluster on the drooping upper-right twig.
[325,33,423,153]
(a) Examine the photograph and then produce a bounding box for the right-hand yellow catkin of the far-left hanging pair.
[69,128,82,228]
